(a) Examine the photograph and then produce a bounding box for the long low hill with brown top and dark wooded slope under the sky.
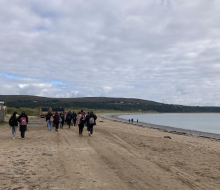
[0,95,220,113]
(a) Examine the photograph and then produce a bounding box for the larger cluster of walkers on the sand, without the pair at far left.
[46,110,97,136]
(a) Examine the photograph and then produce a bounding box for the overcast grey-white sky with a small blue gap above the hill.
[0,0,220,106]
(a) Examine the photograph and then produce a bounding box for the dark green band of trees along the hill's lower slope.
[5,100,220,113]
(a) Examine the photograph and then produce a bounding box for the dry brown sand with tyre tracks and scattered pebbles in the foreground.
[0,117,220,190]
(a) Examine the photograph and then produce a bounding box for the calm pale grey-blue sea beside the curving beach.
[119,114,220,134]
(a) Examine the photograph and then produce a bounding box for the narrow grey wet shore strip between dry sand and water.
[100,113,220,140]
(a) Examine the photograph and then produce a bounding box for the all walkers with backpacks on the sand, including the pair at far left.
[9,110,97,139]
